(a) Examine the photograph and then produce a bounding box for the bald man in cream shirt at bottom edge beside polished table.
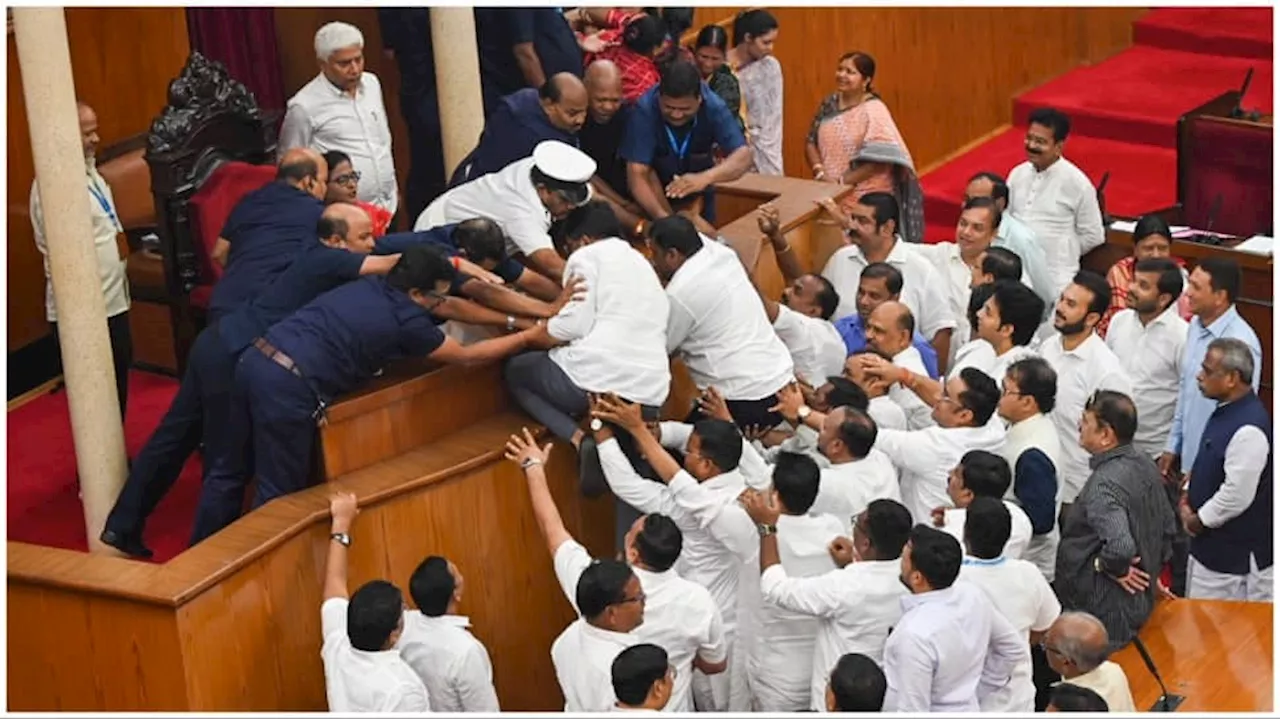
[1041,612,1137,713]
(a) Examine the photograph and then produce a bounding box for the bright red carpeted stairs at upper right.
[922,8,1272,242]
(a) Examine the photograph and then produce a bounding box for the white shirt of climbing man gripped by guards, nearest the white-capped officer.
[547,238,671,407]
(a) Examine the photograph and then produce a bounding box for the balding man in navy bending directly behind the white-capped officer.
[449,73,588,188]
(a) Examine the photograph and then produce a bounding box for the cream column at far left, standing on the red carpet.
[13,6,125,553]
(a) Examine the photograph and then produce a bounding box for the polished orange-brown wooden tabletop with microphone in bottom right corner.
[1111,599,1275,713]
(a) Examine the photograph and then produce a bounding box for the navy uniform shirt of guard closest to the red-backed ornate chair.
[209,180,324,322]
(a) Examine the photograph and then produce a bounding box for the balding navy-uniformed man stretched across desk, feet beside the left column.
[101,202,399,558]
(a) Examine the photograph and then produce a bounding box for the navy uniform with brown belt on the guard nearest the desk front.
[232,278,444,516]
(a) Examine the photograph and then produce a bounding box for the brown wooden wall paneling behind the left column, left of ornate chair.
[6,8,191,352]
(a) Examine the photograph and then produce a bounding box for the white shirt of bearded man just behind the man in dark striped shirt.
[1039,333,1133,504]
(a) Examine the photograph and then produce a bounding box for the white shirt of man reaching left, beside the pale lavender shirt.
[760,559,908,711]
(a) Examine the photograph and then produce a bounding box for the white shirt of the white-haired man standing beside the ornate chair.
[279,73,399,215]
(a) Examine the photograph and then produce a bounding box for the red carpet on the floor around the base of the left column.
[8,371,200,562]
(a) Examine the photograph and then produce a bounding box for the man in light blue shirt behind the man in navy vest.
[1160,257,1262,481]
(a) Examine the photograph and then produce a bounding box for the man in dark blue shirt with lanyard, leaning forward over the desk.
[620,60,751,237]
